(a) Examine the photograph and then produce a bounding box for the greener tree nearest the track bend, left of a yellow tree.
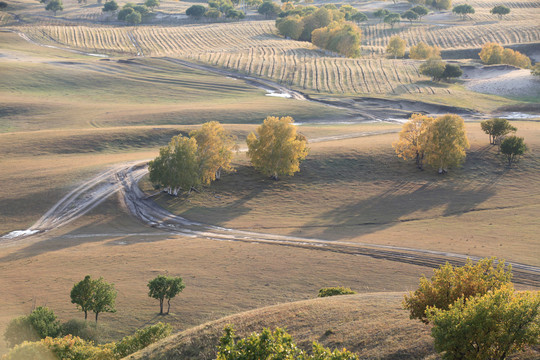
[148,135,201,196]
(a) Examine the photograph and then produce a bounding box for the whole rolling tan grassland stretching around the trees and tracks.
[0,0,540,360]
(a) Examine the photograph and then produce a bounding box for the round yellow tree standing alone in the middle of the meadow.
[246,116,308,180]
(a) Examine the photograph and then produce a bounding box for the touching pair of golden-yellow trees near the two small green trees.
[392,114,469,174]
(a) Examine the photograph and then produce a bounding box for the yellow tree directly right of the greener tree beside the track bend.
[189,121,236,185]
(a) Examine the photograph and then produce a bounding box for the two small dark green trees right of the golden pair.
[480,118,527,166]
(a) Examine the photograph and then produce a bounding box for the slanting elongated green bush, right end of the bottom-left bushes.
[114,322,172,359]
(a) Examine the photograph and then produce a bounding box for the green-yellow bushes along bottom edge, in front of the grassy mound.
[216,326,358,360]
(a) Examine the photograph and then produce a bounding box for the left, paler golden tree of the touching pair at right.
[392,114,435,169]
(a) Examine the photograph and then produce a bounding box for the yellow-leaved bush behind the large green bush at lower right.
[403,258,512,323]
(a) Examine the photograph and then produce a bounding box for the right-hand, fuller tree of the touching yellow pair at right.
[424,114,470,174]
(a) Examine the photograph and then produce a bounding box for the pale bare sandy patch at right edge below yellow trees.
[462,65,540,97]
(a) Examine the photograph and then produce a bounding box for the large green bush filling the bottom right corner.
[428,285,540,360]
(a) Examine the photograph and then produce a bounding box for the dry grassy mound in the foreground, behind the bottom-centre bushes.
[126,293,434,360]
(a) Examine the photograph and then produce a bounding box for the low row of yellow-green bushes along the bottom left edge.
[2,322,172,360]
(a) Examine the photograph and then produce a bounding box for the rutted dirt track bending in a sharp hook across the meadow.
[3,153,540,287]
